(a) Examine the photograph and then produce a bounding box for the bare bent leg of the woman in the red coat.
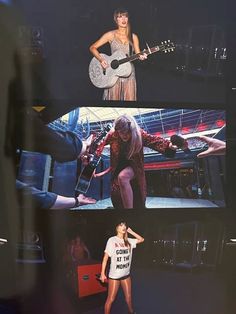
[118,167,134,208]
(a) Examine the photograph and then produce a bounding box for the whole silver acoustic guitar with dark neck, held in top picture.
[89,40,175,88]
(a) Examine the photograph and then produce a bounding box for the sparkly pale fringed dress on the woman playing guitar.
[103,32,137,101]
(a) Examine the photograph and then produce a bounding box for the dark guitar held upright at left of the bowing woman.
[75,124,111,194]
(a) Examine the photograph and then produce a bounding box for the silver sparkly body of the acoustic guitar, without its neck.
[89,51,132,88]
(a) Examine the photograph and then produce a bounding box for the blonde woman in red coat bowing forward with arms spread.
[94,114,187,209]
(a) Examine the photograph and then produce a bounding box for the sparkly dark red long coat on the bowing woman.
[98,129,175,209]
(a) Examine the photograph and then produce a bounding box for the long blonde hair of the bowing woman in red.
[114,114,142,159]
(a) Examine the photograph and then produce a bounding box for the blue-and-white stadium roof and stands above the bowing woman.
[49,107,225,142]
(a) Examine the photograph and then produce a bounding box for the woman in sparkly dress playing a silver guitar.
[89,9,147,101]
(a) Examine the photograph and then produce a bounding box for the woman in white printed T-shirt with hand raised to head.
[100,222,144,314]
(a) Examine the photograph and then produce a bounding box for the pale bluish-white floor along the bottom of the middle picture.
[79,196,218,210]
